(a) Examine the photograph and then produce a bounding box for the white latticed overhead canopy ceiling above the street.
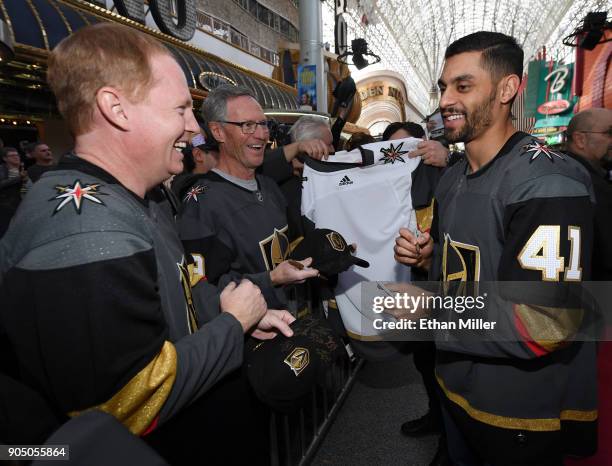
[324,0,612,113]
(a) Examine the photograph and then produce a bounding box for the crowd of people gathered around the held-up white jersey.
[0,20,612,466]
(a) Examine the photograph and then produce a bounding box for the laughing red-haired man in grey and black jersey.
[0,23,293,454]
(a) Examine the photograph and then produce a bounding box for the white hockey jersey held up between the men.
[302,138,421,339]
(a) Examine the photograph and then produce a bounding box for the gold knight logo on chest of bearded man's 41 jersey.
[442,234,480,295]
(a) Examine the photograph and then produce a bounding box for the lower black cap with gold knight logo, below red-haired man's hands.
[244,315,346,412]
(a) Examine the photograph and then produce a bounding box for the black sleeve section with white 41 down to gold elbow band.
[498,178,594,356]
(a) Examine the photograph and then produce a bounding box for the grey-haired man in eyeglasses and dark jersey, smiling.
[178,86,317,314]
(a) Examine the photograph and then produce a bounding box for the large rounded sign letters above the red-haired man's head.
[101,0,196,42]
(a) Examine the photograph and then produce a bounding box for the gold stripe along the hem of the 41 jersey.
[436,374,597,432]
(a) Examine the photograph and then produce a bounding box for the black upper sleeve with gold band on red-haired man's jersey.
[1,233,176,432]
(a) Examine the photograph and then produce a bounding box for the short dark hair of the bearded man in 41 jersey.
[444,31,523,83]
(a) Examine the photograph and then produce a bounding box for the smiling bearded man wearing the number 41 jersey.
[395,32,597,466]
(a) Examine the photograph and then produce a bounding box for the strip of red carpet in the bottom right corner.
[565,341,612,466]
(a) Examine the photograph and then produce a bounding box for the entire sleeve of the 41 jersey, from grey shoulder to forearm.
[435,165,594,359]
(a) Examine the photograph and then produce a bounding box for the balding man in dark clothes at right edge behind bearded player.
[567,108,612,280]
